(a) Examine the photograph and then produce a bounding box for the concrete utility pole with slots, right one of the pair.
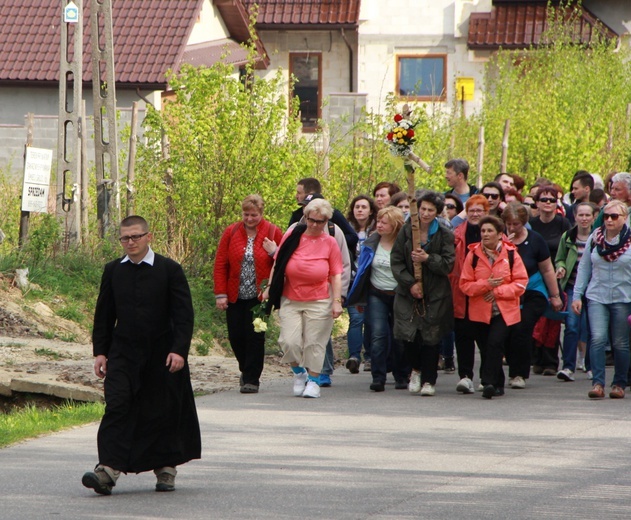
[90,0,121,237]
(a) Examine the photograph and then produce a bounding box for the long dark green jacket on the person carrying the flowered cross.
[390,221,456,345]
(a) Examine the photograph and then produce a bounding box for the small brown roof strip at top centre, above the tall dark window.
[243,0,361,29]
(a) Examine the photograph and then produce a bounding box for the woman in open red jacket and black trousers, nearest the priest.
[214,195,283,394]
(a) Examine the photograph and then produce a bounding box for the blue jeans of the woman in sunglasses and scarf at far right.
[587,300,631,388]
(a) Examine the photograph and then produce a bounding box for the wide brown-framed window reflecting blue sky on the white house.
[397,55,447,101]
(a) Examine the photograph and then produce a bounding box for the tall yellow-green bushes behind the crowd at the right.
[468,7,631,187]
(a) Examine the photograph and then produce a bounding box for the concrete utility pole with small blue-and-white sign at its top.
[57,0,83,247]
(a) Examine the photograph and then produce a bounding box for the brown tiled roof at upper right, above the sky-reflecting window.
[467,0,617,49]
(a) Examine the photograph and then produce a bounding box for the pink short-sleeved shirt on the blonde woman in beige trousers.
[283,232,342,302]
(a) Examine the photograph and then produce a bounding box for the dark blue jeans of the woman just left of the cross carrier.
[366,290,409,383]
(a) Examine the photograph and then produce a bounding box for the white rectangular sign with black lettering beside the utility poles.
[22,147,53,213]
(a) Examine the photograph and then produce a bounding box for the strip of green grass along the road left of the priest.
[0,401,105,448]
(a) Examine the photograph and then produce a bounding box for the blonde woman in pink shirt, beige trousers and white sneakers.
[269,199,342,397]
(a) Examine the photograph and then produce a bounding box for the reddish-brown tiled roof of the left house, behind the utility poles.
[0,0,264,88]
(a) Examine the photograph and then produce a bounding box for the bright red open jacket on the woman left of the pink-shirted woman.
[214,219,283,303]
